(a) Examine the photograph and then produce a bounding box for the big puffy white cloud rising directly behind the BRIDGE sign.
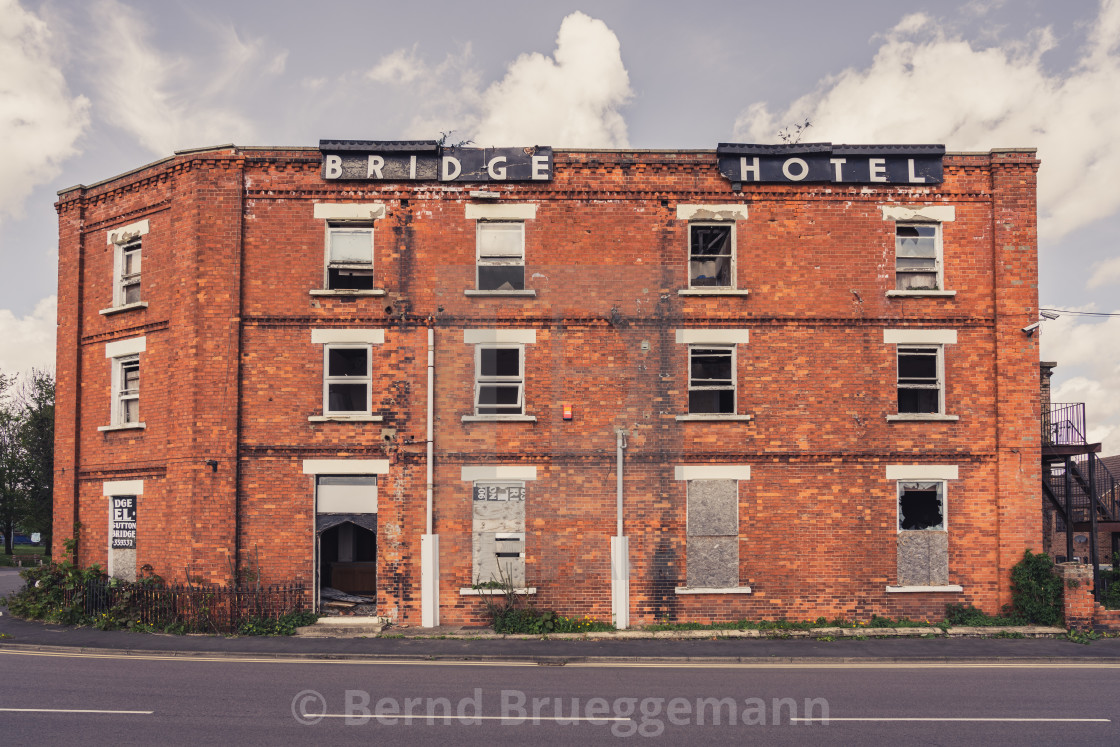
[364,12,632,148]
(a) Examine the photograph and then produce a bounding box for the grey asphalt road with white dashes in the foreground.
[0,651,1120,745]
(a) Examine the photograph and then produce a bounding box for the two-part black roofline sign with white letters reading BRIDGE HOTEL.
[319,140,945,188]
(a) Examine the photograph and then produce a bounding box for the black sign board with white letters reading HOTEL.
[716,142,945,185]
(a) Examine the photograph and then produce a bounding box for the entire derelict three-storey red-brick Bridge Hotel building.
[54,140,1042,626]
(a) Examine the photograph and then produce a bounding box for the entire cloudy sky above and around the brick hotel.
[0,0,1120,454]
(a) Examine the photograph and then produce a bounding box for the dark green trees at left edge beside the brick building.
[0,371,55,554]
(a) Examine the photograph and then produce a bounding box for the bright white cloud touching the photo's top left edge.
[0,0,90,217]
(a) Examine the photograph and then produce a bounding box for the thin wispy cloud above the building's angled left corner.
[87,0,262,156]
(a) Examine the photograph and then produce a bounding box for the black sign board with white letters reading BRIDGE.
[319,140,552,181]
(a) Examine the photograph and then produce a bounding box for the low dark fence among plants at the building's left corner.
[64,579,310,633]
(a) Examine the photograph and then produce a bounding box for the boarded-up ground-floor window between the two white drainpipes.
[472,483,525,588]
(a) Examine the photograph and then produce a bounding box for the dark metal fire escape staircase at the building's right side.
[1042,402,1120,598]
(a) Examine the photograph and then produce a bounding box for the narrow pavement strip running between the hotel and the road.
[0,569,1120,666]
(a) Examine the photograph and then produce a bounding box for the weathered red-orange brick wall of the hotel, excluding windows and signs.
[56,145,1040,623]
